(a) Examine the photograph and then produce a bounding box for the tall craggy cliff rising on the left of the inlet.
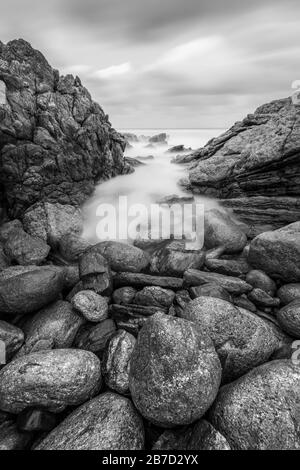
[0,40,125,216]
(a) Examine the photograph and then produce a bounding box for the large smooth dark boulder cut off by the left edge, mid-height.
[0,266,64,315]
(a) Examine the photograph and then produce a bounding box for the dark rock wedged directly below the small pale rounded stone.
[73,318,117,355]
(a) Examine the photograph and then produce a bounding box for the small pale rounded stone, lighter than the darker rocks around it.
[72,290,108,323]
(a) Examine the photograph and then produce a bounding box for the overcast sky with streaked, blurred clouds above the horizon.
[0,0,300,128]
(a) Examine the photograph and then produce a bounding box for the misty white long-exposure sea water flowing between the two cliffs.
[82,129,223,243]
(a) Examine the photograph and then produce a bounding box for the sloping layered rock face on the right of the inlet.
[188,98,300,233]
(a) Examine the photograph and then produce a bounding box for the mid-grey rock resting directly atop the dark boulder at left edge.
[4,230,50,266]
